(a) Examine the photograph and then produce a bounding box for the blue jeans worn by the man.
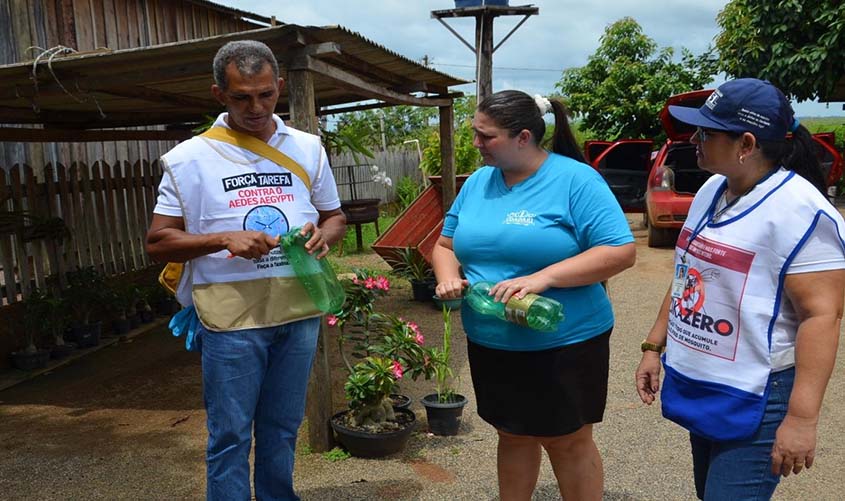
[199,318,320,501]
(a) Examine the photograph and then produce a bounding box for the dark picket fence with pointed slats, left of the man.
[0,161,161,304]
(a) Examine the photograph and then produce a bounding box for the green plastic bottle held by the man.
[279,228,346,314]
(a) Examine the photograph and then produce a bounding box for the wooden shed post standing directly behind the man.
[287,70,334,452]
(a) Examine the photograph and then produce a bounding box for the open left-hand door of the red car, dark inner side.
[592,139,652,212]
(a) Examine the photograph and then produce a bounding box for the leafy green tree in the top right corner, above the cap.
[716,0,845,100]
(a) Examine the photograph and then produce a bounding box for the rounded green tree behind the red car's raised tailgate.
[555,17,715,140]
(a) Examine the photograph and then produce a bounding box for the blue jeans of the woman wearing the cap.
[690,368,795,501]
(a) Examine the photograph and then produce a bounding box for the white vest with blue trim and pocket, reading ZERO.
[661,169,845,440]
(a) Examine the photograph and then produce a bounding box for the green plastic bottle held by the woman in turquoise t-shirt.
[464,282,563,332]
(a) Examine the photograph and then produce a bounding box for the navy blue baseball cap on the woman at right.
[669,78,798,141]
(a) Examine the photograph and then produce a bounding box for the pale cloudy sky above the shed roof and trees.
[214,0,845,117]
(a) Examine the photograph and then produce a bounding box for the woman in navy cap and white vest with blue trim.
[636,78,845,500]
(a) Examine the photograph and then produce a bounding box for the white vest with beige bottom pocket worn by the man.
[162,127,323,331]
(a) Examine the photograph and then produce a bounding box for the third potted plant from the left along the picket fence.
[66,266,107,348]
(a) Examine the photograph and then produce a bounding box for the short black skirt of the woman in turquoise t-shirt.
[467,329,613,437]
